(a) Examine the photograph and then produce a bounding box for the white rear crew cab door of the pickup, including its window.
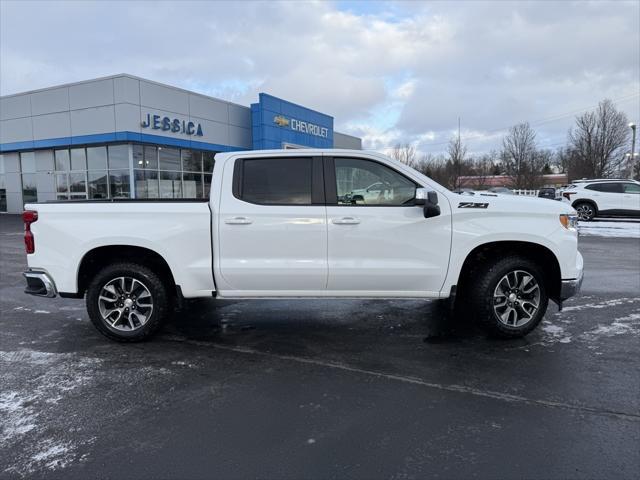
[214,155,327,296]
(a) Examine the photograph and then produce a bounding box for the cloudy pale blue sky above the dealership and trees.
[0,0,640,153]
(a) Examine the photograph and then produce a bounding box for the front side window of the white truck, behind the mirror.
[334,158,416,206]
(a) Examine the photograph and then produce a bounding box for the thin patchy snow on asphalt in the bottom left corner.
[0,348,178,477]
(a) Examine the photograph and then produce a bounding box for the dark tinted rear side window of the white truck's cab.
[236,158,312,205]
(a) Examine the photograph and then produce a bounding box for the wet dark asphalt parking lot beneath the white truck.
[0,215,640,479]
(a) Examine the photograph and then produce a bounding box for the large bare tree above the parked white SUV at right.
[569,99,629,178]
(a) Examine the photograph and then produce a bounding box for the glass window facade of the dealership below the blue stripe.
[0,143,216,208]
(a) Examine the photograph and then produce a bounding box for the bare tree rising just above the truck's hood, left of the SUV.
[501,122,546,188]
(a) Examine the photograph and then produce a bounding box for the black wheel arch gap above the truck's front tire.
[456,240,562,300]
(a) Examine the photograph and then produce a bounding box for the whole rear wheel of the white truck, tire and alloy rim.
[86,263,170,342]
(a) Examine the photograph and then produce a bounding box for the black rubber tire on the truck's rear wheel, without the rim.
[86,262,172,342]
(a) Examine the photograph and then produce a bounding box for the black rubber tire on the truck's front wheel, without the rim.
[467,255,549,338]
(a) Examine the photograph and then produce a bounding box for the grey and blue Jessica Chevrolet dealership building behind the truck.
[0,74,362,213]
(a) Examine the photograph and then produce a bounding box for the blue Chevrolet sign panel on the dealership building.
[251,93,333,150]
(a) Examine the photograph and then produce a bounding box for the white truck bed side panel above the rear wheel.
[25,199,215,298]
